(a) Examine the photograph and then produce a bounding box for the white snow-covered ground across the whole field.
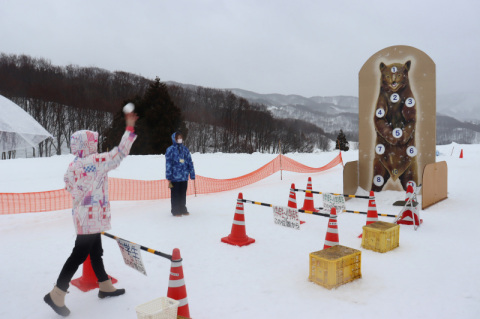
[0,145,480,319]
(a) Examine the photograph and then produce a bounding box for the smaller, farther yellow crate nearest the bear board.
[362,221,400,253]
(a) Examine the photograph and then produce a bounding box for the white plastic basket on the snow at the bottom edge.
[135,297,179,319]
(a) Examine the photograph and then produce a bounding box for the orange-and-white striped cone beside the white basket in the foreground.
[167,248,190,318]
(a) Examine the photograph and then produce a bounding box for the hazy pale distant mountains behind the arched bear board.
[171,82,480,144]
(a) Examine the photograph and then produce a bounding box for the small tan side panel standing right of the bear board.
[422,162,448,209]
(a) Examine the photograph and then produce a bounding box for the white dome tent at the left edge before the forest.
[0,95,53,154]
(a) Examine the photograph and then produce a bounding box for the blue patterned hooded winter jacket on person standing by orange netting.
[165,133,195,182]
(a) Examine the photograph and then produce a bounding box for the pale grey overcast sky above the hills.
[0,0,480,97]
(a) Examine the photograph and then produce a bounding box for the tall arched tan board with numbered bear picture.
[359,46,436,192]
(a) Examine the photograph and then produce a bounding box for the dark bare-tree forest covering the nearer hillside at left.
[0,54,332,158]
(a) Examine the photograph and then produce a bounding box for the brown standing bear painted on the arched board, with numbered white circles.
[372,61,418,192]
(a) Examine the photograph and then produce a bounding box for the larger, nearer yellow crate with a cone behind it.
[308,245,362,289]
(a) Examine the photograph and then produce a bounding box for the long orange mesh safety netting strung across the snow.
[0,153,343,215]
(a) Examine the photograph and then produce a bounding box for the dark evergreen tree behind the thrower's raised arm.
[106,77,188,155]
